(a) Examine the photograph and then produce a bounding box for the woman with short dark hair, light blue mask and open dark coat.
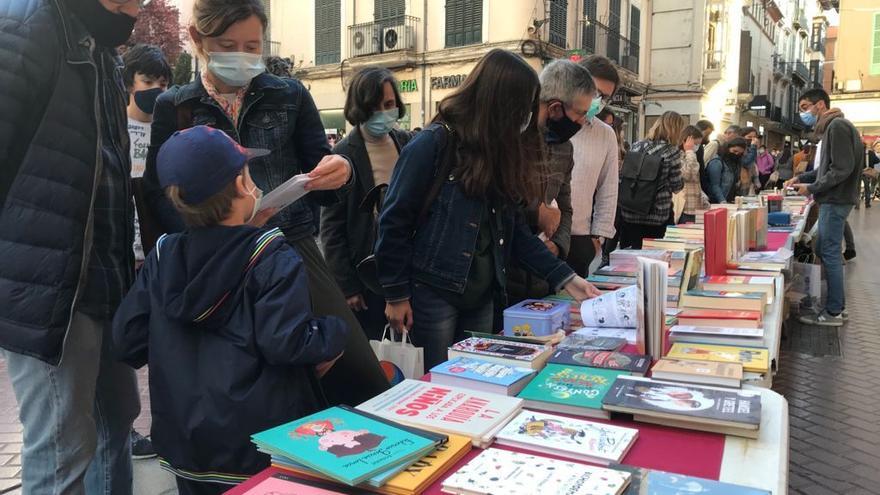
[321,67,410,339]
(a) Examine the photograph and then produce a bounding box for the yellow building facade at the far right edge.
[831,0,880,142]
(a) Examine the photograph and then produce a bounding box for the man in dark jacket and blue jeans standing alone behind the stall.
[786,89,865,327]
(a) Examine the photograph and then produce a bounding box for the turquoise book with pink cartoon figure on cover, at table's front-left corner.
[251,407,436,485]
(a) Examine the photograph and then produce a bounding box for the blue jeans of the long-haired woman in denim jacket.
[410,282,494,371]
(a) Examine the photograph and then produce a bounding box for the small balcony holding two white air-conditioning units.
[348,15,419,57]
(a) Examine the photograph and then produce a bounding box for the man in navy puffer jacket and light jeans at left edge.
[0,0,146,494]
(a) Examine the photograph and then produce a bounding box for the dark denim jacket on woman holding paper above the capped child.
[144,73,354,240]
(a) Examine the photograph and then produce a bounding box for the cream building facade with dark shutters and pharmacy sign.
[269,0,647,140]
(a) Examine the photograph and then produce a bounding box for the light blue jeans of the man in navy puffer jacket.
[3,313,140,495]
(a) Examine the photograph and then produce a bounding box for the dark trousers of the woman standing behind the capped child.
[288,237,389,406]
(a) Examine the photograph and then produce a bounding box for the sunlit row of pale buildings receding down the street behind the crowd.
[643,0,828,147]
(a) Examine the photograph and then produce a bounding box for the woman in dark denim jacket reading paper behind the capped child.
[144,0,388,404]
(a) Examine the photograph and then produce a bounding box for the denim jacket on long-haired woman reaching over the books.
[376,125,574,302]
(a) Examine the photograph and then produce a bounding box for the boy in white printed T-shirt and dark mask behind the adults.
[122,41,171,459]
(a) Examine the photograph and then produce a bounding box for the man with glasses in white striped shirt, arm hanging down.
[566,55,620,277]
